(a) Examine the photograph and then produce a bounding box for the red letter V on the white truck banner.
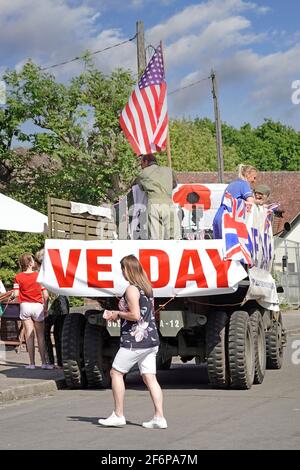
[48,249,81,287]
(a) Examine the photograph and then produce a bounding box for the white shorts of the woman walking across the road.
[112,346,158,374]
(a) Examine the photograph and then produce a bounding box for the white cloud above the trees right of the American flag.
[171,43,300,129]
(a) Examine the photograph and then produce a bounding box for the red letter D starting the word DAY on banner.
[139,250,170,289]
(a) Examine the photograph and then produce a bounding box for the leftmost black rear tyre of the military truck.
[62,313,86,388]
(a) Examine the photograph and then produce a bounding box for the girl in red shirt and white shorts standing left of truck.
[14,253,52,369]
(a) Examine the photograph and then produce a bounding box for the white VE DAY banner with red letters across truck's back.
[38,239,247,297]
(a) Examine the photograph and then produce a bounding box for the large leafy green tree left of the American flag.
[2,62,136,210]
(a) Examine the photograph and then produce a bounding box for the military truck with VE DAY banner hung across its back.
[40,185,286,389]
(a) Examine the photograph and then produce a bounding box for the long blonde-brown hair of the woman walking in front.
[120,255,153,297]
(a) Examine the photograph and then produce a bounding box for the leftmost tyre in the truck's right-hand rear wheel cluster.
[206,311,229,387]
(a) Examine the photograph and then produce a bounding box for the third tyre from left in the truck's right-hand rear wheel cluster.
[249,309,266,384]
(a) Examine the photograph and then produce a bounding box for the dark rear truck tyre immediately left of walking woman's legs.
[84,323,111,388]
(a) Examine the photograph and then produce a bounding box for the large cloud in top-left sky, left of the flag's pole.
[0,0,136,79]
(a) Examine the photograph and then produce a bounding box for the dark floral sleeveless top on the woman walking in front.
[119,286,159,349]
